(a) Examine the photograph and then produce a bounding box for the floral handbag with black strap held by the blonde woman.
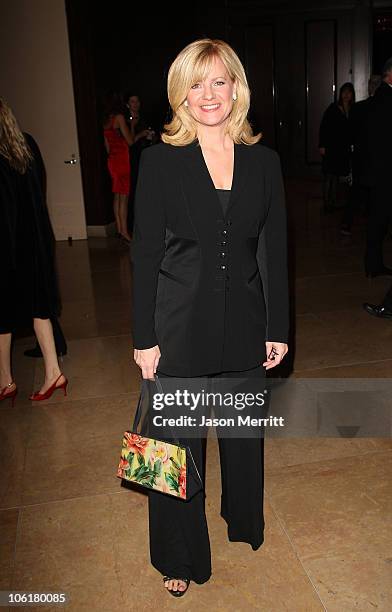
[117,377,203,500]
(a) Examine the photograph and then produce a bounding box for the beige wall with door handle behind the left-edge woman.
[0,0,86,240]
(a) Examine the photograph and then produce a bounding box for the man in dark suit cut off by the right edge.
[365,57,392,277]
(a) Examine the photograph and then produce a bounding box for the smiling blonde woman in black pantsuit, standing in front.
[132,39,288,596]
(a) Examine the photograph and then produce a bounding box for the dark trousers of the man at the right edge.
[365,185,392,273]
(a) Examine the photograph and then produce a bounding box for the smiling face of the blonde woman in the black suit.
[186,57,236,126]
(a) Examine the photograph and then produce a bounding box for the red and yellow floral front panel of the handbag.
[117,431,187,499]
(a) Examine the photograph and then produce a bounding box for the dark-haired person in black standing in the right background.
[319,83,355,212]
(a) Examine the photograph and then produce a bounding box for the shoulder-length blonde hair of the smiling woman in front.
[161,38,261,146]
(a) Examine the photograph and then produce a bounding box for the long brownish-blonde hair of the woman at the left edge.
[0,97,33,174]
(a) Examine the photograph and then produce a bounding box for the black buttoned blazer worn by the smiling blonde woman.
[131,141,288,377]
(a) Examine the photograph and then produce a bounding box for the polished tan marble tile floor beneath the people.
[0,180,392,612]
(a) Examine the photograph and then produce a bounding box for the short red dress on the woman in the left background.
[104,116,131,195]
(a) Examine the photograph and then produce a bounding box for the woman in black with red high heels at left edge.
[0,98,68,401]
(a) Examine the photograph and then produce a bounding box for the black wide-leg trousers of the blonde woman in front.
[148,366,265,584]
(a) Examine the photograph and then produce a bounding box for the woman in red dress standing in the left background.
[103,95,135,242]
